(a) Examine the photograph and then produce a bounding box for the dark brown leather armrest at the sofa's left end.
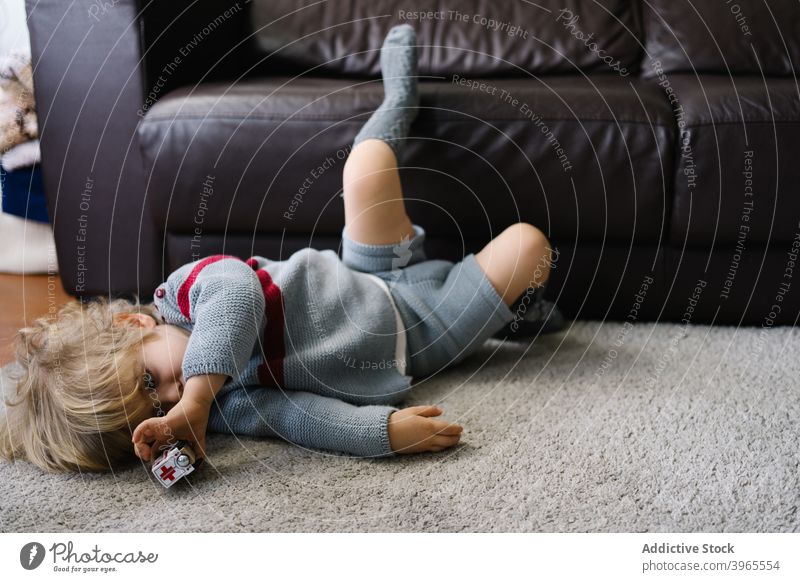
[26,0,161,300]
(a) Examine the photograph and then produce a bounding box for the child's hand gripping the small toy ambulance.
[133,394,211,461]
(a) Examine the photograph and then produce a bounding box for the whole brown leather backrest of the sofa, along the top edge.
[141,0,800,94]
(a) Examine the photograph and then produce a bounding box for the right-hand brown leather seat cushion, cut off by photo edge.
[668,74,800,248]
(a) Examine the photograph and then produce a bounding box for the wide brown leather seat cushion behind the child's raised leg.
[138,75,674,243]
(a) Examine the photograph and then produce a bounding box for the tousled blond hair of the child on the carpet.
[0,297,161,471]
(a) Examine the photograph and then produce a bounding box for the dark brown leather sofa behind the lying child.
[28,0,800,328]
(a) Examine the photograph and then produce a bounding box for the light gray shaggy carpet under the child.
[0,322,800,532]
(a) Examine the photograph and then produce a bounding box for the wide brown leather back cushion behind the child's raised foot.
[249,0,642,77]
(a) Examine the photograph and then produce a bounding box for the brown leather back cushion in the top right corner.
[642,0,800,76]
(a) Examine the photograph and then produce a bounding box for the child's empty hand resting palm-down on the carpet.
[389,406,464,455]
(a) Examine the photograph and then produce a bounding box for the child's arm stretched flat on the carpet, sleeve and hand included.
[208,386,463,457]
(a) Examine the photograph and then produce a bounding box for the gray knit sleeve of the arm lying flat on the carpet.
[208,386,398,457]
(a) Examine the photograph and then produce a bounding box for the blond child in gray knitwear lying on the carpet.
[0,24,563,470]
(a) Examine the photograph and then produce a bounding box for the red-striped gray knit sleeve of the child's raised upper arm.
[155,255,264,388]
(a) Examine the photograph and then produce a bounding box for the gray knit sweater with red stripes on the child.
[153,253,412,456]
